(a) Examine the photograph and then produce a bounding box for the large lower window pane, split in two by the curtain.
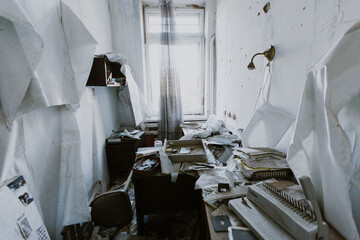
[147,42,203,115]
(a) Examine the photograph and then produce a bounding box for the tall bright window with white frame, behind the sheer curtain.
[144,7,205,115]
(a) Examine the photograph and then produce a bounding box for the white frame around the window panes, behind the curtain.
[143,6,208,119]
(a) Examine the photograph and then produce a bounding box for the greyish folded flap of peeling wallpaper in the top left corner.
[0,0,44,125]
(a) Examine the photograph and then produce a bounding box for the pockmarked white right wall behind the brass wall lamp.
[216,0,360,128]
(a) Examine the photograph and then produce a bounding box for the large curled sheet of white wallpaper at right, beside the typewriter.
[288,24,360,239]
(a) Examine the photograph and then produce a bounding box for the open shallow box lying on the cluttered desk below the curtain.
[164,139,207,163]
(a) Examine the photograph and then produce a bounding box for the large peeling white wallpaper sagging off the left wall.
[0,0,96,238]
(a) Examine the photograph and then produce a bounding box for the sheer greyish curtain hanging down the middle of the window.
[158,0,182,139]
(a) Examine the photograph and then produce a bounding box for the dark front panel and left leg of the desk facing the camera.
[133,171,202,235]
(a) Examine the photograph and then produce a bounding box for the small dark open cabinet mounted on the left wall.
[86,55,126,87]
